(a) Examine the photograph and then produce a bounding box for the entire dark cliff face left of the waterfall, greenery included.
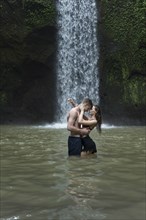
[0,1,56,124]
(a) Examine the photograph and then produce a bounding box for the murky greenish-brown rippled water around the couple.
[0,126,146,220]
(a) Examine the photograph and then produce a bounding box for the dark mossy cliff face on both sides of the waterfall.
[0,0,146,124]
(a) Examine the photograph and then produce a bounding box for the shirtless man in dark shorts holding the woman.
[67,98,93,156]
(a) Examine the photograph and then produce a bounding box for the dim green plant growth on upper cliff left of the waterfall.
[0,0,56,106]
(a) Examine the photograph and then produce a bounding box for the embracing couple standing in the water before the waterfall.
[67,98,102,156]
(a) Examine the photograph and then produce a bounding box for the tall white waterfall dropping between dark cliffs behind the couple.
[56,0,99,122]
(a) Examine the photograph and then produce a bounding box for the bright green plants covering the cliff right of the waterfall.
[101,0,146,105]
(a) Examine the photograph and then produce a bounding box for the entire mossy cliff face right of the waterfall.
[98,0,146,124]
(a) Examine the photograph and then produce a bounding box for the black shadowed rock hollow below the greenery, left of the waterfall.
[1,26,56,123]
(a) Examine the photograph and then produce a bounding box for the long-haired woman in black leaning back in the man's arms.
[68,99,102,156]
